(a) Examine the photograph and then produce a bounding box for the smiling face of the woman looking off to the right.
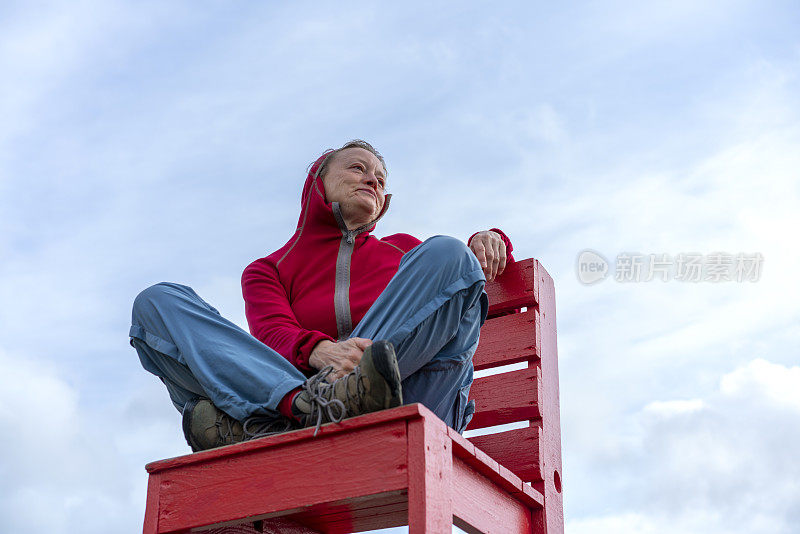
[322,148,386,230]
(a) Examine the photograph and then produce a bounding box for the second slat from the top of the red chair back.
[472,309,539,369]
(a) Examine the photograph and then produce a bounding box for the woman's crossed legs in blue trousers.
[130,236,488,438]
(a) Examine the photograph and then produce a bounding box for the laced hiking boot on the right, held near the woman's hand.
[292,341,403,436]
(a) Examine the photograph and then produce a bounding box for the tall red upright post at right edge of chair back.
[534,262,564,534]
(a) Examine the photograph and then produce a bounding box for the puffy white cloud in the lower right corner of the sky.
[568,359,800,534]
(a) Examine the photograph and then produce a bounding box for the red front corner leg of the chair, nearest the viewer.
[408,418,453,534]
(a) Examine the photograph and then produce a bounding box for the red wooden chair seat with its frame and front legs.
[145,404,544,533]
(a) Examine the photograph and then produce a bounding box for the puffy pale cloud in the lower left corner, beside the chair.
[0,350,187,534]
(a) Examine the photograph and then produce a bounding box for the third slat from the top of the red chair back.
[468,365,541,429]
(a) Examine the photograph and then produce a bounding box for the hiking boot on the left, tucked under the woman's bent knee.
[183,399,296,452]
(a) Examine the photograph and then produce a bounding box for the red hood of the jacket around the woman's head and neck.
[297,150,392,235]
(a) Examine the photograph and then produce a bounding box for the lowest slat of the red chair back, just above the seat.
[467,423,542,482]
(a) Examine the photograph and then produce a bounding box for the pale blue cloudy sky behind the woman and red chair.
[0,0,800,534]
